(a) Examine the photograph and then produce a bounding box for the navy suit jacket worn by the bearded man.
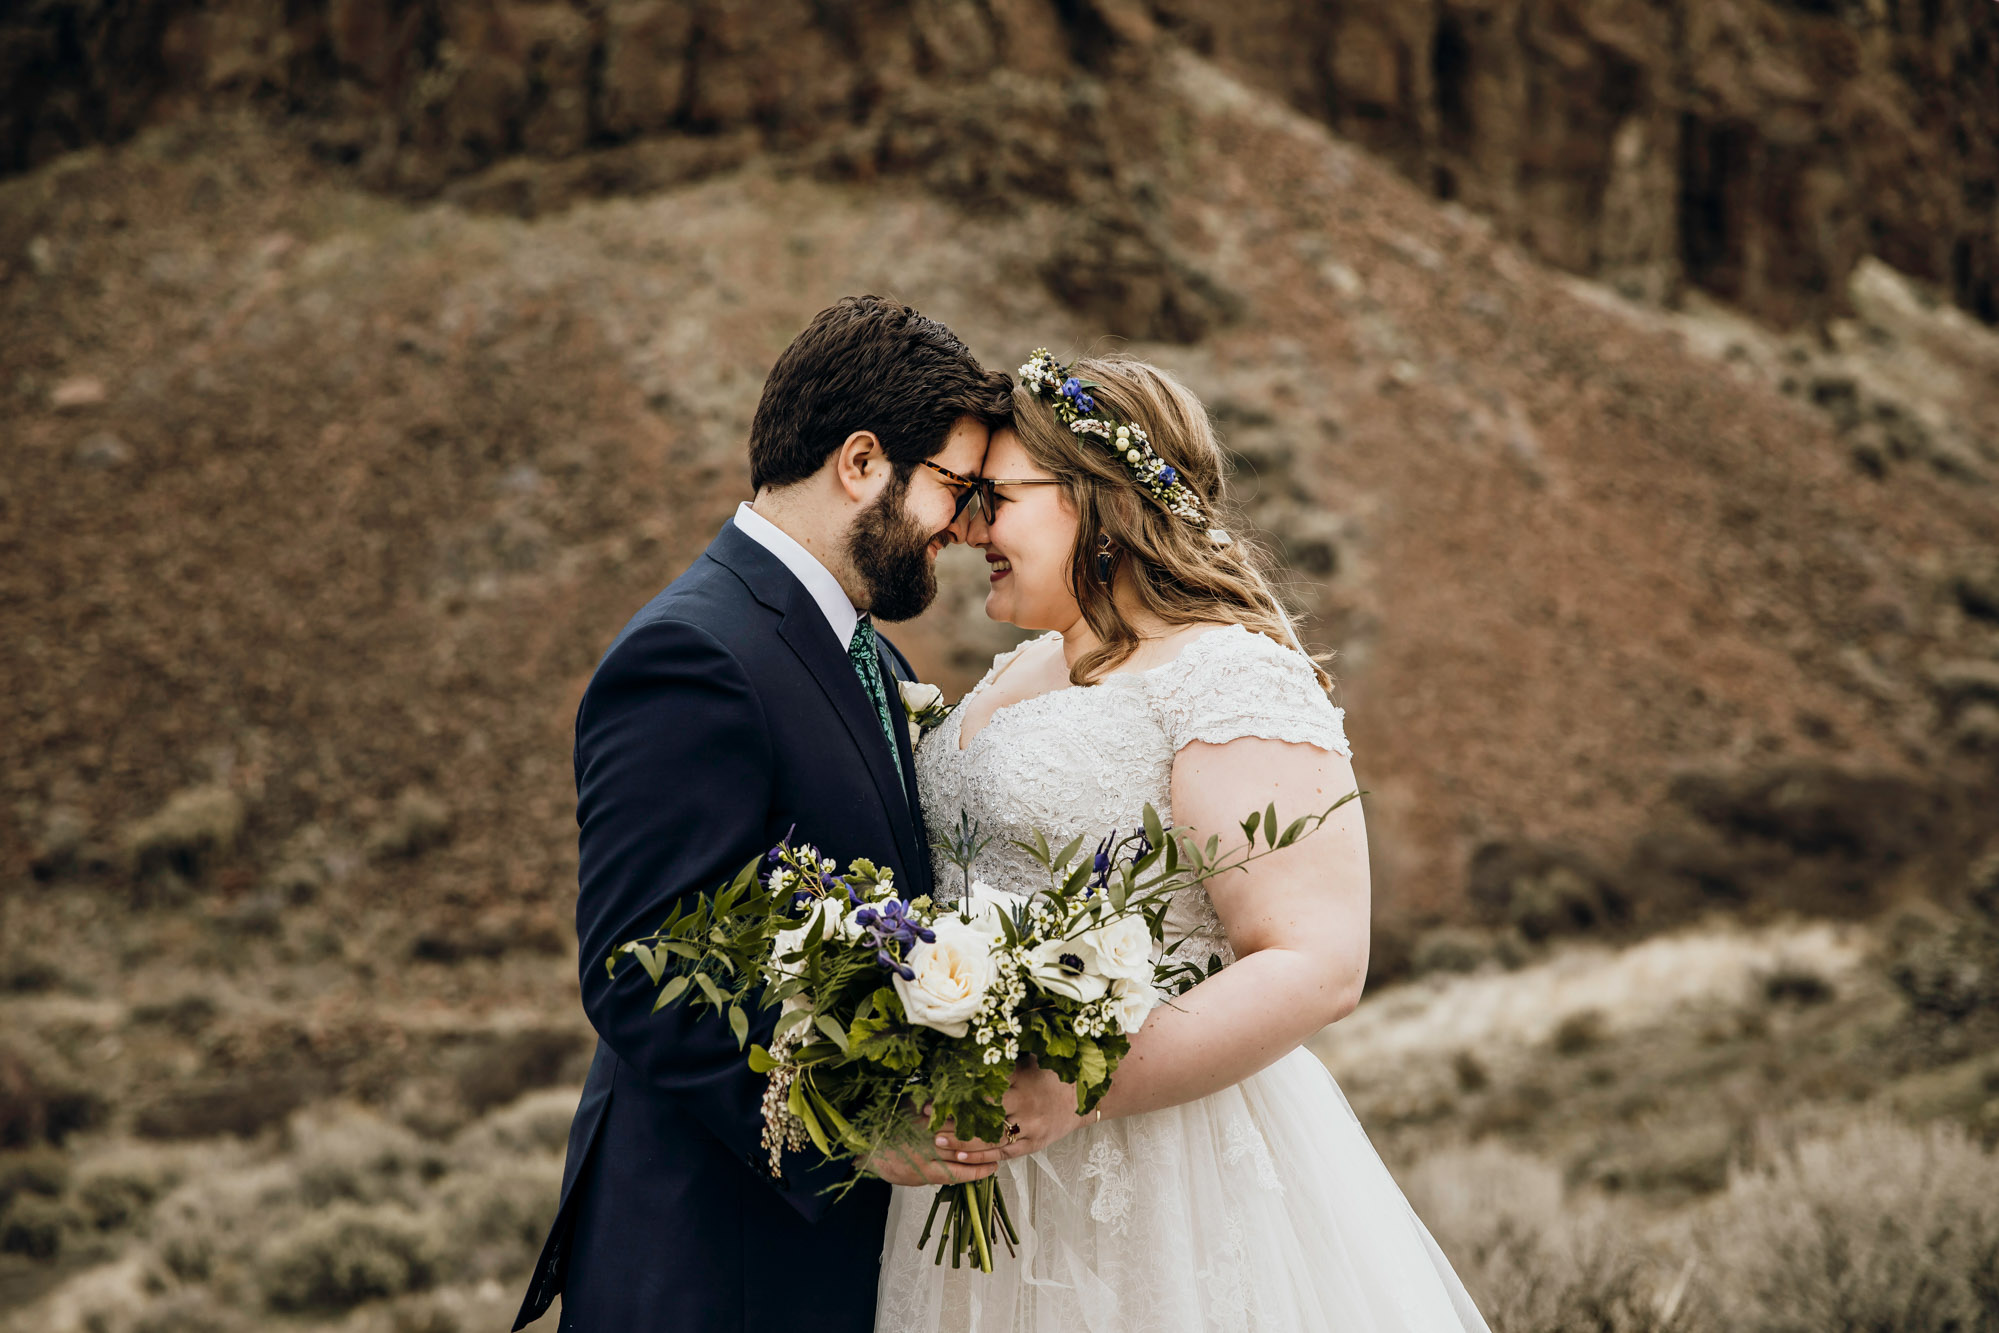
[514,524,930,1333]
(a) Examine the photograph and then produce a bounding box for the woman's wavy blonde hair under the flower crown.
[1013,354,1333,691]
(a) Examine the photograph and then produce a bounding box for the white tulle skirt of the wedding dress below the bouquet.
[876,1049,1485,1333]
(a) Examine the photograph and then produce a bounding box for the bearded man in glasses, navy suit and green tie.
[514,296,1009,1333]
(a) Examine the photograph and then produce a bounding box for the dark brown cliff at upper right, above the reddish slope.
[1155,0,1999,324]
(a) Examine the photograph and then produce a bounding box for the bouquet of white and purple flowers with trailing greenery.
[606,793,1357,1273]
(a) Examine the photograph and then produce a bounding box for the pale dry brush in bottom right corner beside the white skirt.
[1401,1113,1999,1333]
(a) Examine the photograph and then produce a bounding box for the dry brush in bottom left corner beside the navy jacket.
[0,1089,576,1333]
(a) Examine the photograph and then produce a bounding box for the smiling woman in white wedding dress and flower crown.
[876,352,1485,1333]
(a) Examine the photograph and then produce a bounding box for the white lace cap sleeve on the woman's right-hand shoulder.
[1147,626,1353,757]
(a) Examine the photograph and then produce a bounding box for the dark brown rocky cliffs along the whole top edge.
[0,0,1999,336]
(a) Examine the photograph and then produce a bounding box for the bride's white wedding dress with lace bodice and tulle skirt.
[876,626,1485,1333]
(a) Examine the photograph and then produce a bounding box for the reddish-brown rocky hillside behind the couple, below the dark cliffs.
[0,31,1999,931]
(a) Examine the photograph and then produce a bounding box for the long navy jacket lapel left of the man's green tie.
[708,524,930,897]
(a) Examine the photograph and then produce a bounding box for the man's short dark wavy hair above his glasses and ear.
[750,296,1013,490]
